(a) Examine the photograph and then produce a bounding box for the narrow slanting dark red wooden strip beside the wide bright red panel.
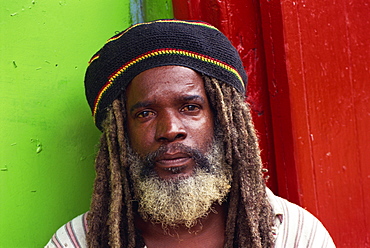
[260,0,302,204]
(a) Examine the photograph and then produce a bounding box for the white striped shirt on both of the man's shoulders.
[45,189,335,248]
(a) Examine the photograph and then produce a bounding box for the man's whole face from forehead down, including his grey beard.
[126,66,231,228]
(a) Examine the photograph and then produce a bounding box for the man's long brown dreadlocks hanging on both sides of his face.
[87,76,274,248]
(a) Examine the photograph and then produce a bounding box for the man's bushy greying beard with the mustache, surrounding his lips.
[128,141,232,228]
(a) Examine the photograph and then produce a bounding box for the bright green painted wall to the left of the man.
[0,0,130,248]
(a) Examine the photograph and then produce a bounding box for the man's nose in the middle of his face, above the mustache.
[155,113,187,143]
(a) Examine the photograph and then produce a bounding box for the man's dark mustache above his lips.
[140,143,211,176]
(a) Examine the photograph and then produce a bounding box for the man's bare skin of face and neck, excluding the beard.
[126,66,225,248]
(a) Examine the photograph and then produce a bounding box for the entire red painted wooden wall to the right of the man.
[173,0,370,247]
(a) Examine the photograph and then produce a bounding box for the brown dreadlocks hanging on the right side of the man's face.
[204,76,273,248]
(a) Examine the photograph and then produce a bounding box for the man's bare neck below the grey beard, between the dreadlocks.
[135,204,226,248]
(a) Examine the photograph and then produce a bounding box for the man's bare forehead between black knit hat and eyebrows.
[126,66,206,104]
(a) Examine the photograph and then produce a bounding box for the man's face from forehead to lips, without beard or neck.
[126,66,214,179]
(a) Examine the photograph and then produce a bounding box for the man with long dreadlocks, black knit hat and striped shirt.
[47,20,334,248]
